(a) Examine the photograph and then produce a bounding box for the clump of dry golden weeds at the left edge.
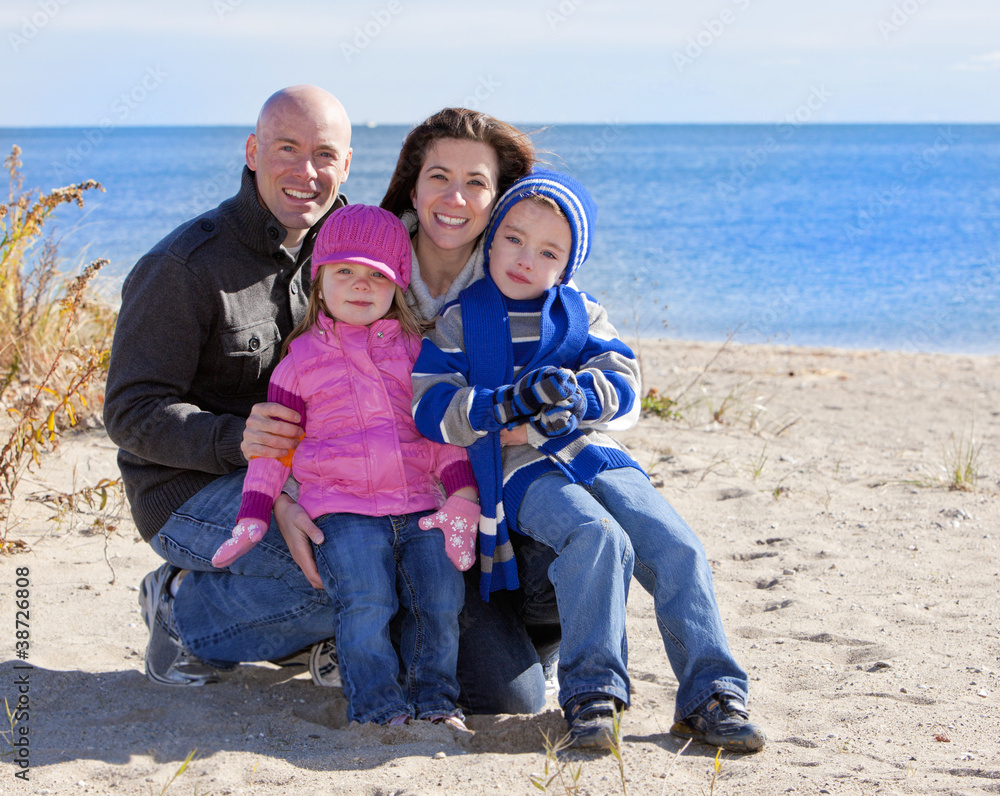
[0,146,115,552]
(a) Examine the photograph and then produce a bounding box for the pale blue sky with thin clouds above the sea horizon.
[0,0,1000,127]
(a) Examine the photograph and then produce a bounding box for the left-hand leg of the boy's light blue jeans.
[517,472,634,707]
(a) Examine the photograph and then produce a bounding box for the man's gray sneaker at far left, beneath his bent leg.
[139,564,219,685]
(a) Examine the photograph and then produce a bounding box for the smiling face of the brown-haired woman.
[410,138,498,255]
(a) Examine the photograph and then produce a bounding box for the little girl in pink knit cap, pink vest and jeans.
[212,205,479,730]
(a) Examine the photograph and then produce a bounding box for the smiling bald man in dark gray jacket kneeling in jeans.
[104,86,351,685]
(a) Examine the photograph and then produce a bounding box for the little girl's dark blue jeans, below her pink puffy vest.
[313,512,465,724]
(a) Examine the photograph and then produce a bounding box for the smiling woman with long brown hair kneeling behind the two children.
[382,108,560,713]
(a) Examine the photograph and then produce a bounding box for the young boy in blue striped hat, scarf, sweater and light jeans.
[413,169,765,752]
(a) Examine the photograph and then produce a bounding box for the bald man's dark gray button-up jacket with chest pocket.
[104,168,346,541]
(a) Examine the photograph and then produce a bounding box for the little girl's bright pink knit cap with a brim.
[312,205,411,290]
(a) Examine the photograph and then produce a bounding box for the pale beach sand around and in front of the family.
[0,341,1000,796]
